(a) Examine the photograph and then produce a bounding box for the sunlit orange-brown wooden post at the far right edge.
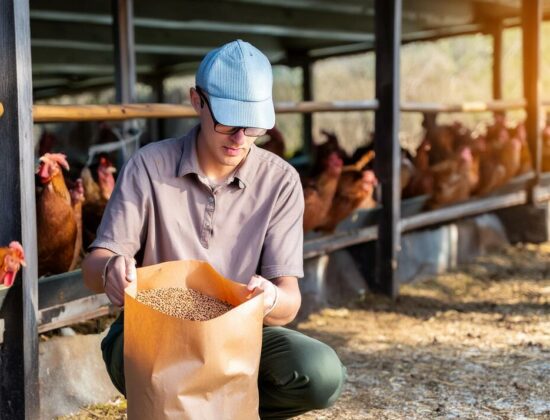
[522,0,542,180]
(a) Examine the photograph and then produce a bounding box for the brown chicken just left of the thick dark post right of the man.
[319,151,377,232]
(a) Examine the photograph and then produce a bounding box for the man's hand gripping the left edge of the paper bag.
[104,255,137,307]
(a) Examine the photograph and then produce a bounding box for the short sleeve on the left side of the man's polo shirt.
[89,152,151,257]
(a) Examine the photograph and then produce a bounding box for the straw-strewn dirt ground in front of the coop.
[58,243,550,420]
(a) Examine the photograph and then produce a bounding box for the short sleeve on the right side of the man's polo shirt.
[260,175,304,279]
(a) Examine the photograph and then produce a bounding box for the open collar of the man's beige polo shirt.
[177,124,258,189]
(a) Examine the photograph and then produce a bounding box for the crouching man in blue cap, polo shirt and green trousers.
[82,40,345,419]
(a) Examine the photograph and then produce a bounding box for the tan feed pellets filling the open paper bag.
[136,287,232,321]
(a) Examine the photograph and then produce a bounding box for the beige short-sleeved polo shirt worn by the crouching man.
[90,126,304,283]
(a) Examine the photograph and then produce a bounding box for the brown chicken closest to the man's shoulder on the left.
[80,155,116,248]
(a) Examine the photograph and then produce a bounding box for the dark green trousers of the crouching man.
[101,313,346,419]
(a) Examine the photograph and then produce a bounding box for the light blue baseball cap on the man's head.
[195,39,275,129]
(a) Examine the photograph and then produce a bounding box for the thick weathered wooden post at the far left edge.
[0,0,40,419]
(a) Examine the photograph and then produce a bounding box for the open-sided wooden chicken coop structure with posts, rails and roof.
[0,0,550,419]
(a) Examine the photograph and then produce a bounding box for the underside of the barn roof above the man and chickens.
[30,0,550,98]
